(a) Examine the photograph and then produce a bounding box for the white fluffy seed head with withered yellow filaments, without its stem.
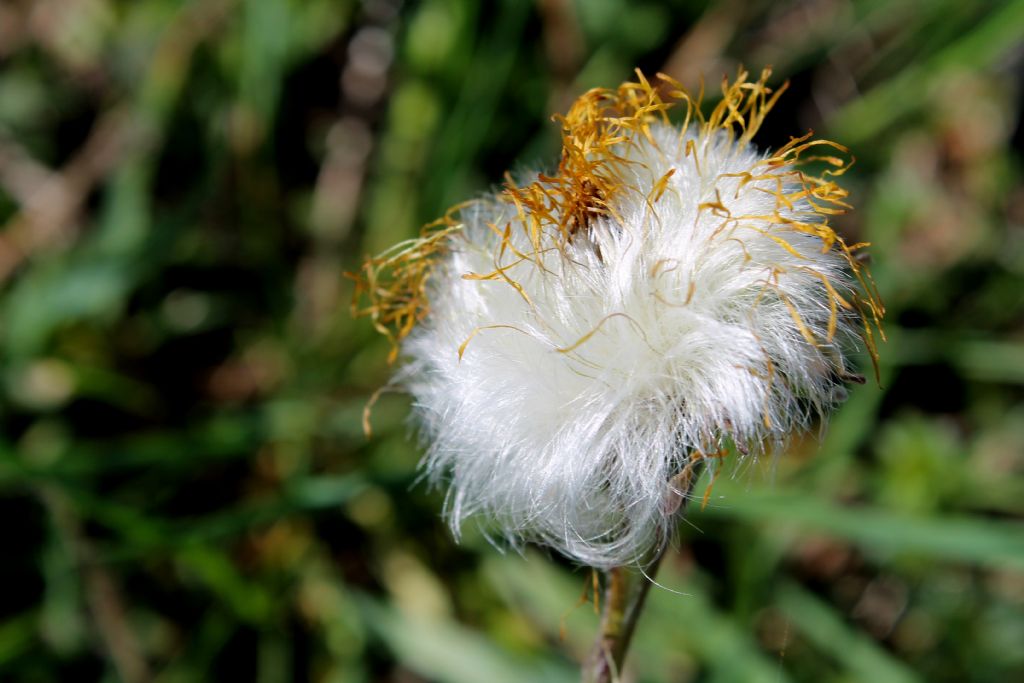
[356,70,881,567]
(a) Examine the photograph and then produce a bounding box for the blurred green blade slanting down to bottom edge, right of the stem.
[776,583,923,683]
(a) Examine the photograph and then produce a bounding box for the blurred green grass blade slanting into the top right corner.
[828,0,1024,144]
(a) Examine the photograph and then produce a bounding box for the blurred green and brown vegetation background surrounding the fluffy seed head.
[0,0,1024,683]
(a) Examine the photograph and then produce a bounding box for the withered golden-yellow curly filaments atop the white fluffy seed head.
[351,69,885,373]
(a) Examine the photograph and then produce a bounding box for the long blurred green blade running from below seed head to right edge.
[690,481,1024,570]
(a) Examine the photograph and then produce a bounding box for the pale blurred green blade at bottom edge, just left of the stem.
[351,593,579,683]
